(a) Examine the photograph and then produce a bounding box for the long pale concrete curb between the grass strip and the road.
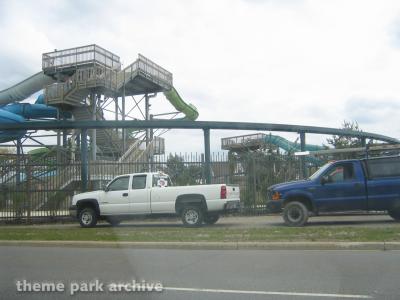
[0,240,400,251]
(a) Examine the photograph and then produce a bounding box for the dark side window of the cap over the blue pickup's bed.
[367,157,400,178]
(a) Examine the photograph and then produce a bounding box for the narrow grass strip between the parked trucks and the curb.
[0,225,400,242]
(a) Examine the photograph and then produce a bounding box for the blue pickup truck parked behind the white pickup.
[267,156,400,226]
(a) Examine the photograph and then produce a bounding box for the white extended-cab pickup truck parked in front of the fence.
[70,172,240,227]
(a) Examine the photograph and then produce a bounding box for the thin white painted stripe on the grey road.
[163,286,372,299]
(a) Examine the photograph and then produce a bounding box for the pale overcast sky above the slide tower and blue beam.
[0,0,400,151]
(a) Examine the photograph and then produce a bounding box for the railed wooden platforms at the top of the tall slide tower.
[42,45,173,107]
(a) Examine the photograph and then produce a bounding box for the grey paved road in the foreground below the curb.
[0,246,400,300]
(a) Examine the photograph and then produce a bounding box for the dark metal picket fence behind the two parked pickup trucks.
[0,153,301,222]
